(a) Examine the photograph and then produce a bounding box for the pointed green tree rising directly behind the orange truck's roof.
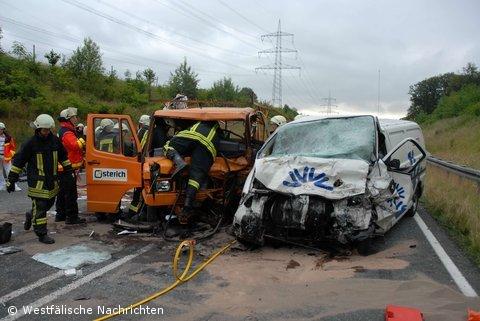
[168,58,200,98]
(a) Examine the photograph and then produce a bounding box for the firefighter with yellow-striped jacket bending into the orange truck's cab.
[164,121,221,224]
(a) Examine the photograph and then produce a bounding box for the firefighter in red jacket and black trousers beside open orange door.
[55,107,86,224]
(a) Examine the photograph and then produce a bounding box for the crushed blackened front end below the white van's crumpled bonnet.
[233,189,375,245]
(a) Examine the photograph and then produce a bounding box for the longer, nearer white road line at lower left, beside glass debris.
[0,244,154,321]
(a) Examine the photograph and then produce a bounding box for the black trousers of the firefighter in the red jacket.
[55,172,78,220]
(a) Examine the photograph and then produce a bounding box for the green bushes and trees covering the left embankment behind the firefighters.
[0,29,297,142]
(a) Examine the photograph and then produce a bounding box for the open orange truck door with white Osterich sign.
[86,114,142,213]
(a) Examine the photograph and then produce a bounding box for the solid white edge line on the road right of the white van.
[414,213,478,298]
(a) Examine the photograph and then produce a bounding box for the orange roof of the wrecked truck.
[153,107,255,121]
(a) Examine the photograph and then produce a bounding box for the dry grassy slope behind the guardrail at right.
[422,116,480,169]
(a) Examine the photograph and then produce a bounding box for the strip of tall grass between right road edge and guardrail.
[422,165,480,266]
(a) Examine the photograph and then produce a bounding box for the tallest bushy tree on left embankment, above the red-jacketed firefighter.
[67,38,103,80]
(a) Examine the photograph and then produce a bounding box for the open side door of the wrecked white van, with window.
[383,138,427,226]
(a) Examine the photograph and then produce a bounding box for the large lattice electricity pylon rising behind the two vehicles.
[255,20,300,107]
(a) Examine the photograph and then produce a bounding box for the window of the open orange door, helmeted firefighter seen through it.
[93,118,121,154]
